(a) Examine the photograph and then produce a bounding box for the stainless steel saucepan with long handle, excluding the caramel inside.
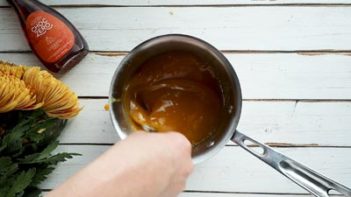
[109,34,351,197]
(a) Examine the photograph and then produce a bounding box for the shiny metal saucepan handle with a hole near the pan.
[232,131,351,197]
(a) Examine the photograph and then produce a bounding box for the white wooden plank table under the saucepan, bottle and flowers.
[0,0,351,197]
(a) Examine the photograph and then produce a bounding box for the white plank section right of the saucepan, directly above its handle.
[238,102,351,146]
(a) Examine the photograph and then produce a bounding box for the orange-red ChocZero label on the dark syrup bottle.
[26,11,74,63]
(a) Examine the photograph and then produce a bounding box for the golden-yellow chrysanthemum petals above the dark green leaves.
[0,62,81,119]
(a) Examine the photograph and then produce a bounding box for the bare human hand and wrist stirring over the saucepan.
[48,132,193,197]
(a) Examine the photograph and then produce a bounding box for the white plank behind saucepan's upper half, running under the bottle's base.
[0,52,351,100]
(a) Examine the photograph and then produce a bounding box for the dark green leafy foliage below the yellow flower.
[0,110,80,197]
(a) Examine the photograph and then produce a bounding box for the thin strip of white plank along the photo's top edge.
[0,0,350,6]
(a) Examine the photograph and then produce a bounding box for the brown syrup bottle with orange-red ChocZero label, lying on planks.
[7,0,89,73]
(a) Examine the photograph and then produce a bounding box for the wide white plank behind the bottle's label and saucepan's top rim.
[0,6,351,51]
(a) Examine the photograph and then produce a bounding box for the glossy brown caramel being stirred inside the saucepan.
[122,51,223,145]
